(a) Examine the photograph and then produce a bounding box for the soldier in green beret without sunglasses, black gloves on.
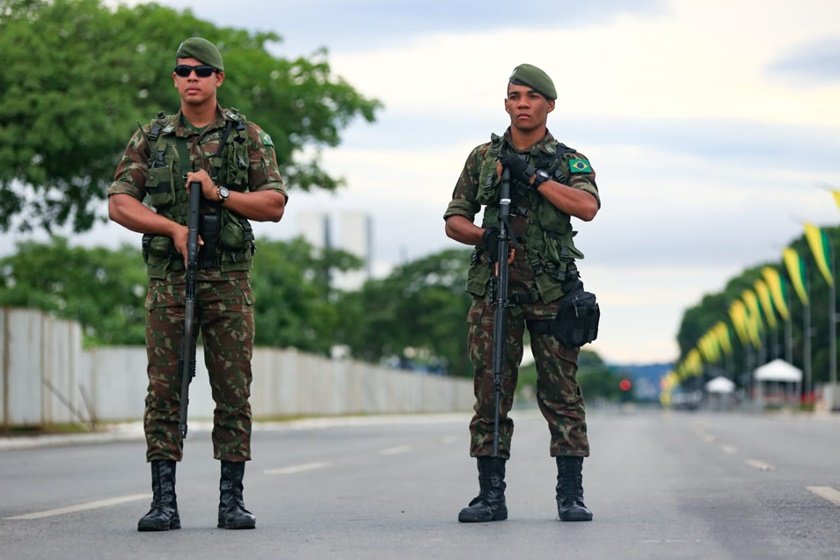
[444,64,601,522]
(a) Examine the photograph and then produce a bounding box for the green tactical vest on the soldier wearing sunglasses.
[143,109,254,279]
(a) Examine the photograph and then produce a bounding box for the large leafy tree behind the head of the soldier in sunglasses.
[0,0,380,231]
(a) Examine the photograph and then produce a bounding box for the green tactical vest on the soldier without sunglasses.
[467,134,583,303]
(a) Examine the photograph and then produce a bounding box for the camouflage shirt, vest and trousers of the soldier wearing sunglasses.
[108,107,286,461]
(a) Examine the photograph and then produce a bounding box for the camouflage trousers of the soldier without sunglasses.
[467,298,589,459]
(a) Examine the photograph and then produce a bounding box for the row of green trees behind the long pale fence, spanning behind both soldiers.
[0,236,616,378]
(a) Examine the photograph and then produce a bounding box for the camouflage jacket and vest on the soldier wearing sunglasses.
[108,107,286,278]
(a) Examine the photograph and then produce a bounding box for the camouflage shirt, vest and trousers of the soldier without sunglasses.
[444,130,600,459]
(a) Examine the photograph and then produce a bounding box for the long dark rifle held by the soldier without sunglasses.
[493,167,510,457]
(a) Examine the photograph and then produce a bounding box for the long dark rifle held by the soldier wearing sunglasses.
[178,181,201,439]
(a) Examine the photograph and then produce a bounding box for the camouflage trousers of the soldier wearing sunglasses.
[143,272,254,461]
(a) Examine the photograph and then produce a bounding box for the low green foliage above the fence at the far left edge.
[0,237,146,344]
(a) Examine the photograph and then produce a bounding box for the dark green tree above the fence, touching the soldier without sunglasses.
[338,249,480,376]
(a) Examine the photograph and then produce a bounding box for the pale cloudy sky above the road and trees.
[8,0,840,363]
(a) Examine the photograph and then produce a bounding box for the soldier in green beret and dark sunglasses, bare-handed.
[108,37,287,531]
